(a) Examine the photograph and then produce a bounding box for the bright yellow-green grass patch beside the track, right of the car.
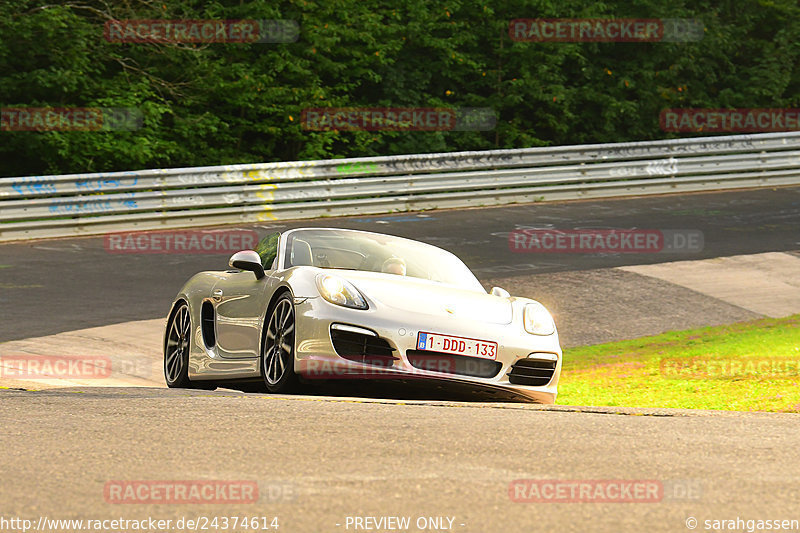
[558,315,800,412]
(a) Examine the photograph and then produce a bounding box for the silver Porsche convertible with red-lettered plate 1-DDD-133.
[164,228,561,403]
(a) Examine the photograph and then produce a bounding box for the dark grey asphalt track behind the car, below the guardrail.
[0,187,800,343]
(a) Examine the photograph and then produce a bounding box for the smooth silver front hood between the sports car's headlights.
[330,270,512,324]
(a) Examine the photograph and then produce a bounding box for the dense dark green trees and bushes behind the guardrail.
[0,0,800,176]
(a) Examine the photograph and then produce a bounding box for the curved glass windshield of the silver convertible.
[285,229,483,291]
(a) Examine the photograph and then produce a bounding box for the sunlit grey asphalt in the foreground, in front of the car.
[0,389,800,533]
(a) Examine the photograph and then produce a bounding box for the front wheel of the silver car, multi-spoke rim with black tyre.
[261,292,298,393]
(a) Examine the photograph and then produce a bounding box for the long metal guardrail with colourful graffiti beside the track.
[0,132,800,241]
